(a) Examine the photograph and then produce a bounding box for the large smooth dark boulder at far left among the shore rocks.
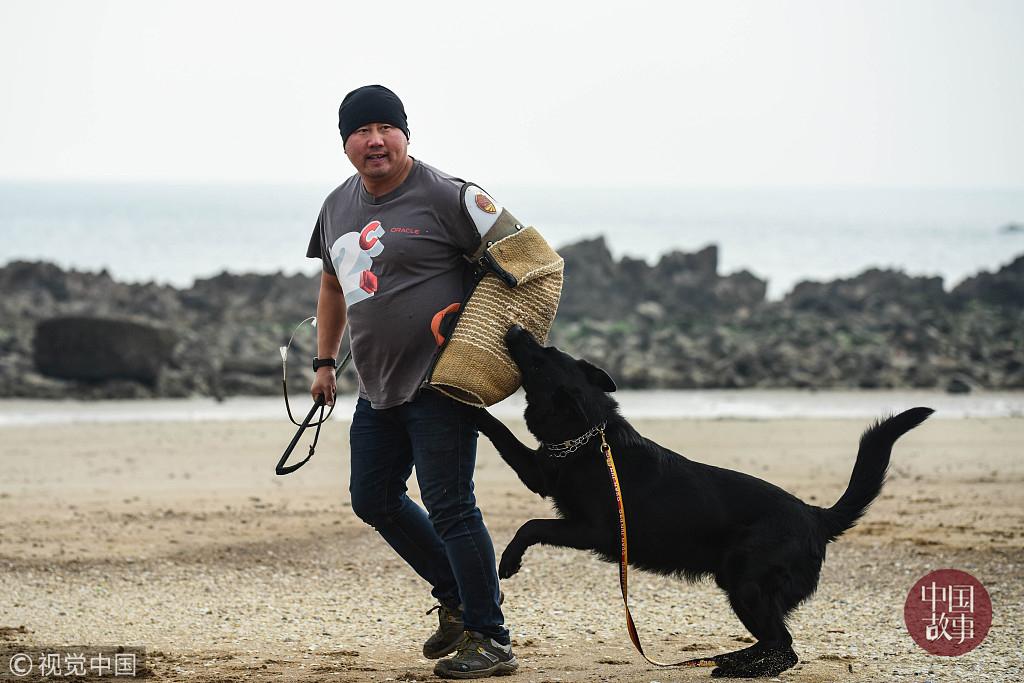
[33,316,174,393]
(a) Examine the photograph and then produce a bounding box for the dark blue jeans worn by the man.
[349,389,509,643]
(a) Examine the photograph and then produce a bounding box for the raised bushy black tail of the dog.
[821,408,935,541]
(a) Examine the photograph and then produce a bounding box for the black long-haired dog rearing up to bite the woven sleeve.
[477,326,933,678]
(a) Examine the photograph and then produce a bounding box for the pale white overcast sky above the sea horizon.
[0,0,1024,187]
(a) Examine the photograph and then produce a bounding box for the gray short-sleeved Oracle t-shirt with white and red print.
[306,160,495,409]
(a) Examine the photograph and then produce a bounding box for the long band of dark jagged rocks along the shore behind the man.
[6,248,1024,398]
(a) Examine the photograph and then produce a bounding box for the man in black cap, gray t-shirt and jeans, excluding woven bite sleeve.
[306,85,518,678]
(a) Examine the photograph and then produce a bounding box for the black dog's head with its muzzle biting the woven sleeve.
[505,325,616,443]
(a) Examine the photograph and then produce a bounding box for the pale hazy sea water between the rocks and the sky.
[0,181,1024,298]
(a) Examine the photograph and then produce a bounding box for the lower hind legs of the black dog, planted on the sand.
[711,581,799,678]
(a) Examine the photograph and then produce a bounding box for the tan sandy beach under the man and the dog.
[0,418,1024,683]
